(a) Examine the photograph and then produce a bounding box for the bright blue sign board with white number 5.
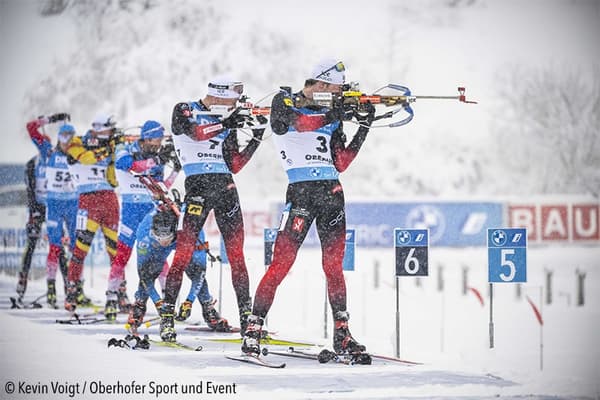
[487,228,527,282]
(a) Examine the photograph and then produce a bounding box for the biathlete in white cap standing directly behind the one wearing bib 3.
[160,79,267,341]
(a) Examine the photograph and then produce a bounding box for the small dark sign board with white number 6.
[394,228,429,276]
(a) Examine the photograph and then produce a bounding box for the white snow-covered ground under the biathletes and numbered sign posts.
[0,247,600,399]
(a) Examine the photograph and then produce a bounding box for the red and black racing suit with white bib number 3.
[252,91,369,318]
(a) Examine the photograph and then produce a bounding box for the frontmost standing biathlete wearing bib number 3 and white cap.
[242,60,375,354]
